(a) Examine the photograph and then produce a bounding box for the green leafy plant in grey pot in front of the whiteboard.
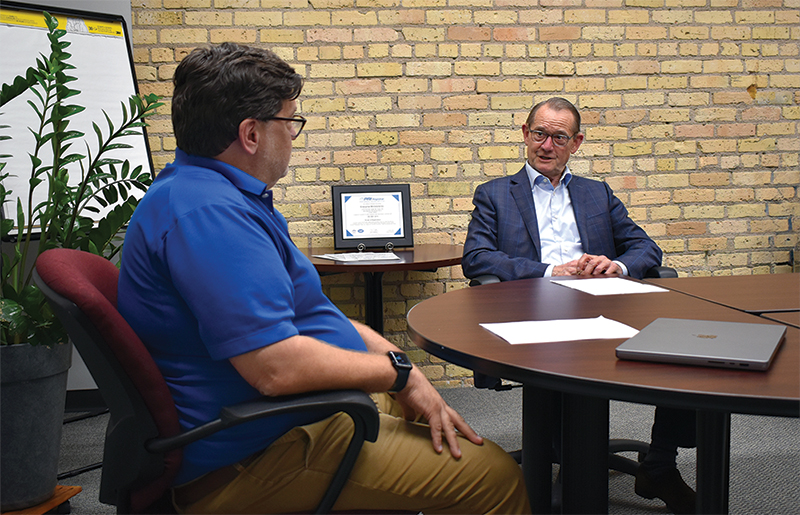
[0,12,163,345]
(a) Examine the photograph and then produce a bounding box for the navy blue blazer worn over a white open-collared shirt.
[461,167,662,281]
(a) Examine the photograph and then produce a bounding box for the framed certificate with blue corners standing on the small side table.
[332,184,414,250]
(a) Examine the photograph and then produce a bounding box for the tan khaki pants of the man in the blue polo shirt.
[177,394,530,515]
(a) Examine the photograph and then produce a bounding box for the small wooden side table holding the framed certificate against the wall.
[300,243,464,334]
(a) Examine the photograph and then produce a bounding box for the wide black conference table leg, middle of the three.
[561,393,608,513]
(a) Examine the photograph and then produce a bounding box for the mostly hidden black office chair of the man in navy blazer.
[469,266,678,476]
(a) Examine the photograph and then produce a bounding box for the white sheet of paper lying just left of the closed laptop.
[480,316,639,345]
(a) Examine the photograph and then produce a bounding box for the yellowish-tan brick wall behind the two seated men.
[132,0,800,385]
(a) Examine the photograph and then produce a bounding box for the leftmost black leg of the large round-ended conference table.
[522,385,559,513]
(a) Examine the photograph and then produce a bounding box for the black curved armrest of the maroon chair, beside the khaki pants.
[145,390,380,453]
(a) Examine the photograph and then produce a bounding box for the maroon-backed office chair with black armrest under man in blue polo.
[34,249,379,513]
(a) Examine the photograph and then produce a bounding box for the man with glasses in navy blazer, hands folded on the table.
[461,98,696,513]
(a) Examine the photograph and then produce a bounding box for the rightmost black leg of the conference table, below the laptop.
[697,410,731,513]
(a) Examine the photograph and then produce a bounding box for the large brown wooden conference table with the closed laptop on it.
[408,278,800,513]
